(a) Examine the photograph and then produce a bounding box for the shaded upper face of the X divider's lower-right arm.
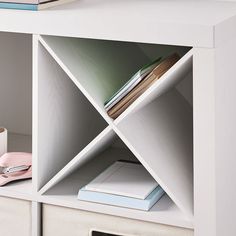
[115,90,193,216]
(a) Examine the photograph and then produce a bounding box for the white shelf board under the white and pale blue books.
[39,173,193,229]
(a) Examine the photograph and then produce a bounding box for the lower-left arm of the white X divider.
[40,126,115,194]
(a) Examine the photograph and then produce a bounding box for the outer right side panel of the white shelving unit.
[214,36,236,236]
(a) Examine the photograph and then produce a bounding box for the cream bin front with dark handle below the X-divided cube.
[43,205,193,236]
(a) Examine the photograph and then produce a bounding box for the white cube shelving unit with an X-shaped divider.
[0,0,236,236]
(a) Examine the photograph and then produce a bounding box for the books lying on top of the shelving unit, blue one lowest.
[0,0,72,11]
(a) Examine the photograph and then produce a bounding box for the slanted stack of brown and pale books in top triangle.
[104,53,180,119]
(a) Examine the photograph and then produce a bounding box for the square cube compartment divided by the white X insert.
[36,33,193,228]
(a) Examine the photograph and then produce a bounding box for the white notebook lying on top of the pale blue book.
[84,161,158,199]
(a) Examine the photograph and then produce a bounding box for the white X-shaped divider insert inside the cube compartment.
[37,37,193,219]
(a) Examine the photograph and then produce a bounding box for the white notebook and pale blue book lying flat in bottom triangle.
[78,161,165,211]
